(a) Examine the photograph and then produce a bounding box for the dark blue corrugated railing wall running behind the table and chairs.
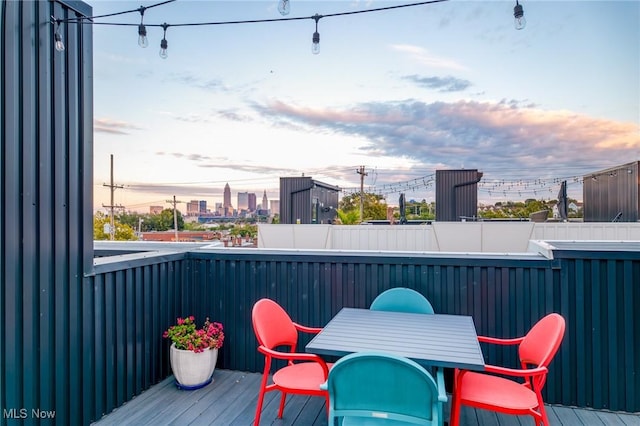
[190,251,640,412]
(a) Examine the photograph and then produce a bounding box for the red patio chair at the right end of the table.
[451,313,565,426]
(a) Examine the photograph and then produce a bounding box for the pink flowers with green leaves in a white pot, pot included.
[163,316,224,390]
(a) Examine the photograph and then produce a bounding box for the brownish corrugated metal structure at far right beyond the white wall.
[582,161,640,222]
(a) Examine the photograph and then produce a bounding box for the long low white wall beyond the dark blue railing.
[258,221,640,253]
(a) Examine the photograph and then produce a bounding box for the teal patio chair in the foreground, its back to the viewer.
[321,352,447,426]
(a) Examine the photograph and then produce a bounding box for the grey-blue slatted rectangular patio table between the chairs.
[305,308,484,371]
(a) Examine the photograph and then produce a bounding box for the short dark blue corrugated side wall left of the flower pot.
[86,254,194,424]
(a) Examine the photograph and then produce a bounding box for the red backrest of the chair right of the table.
[518,313,565,367]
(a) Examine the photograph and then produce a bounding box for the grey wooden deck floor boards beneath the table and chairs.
[94,369,640,426]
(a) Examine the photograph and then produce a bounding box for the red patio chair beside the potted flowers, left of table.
[251,299,331,426]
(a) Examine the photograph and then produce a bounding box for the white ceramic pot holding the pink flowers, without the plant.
[169,344,218,390]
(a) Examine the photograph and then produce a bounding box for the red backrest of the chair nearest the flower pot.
[251,299,298,349]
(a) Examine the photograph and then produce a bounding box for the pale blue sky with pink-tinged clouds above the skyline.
[86,0,640,212]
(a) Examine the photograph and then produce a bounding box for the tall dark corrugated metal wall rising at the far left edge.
[0,1,93,424]
